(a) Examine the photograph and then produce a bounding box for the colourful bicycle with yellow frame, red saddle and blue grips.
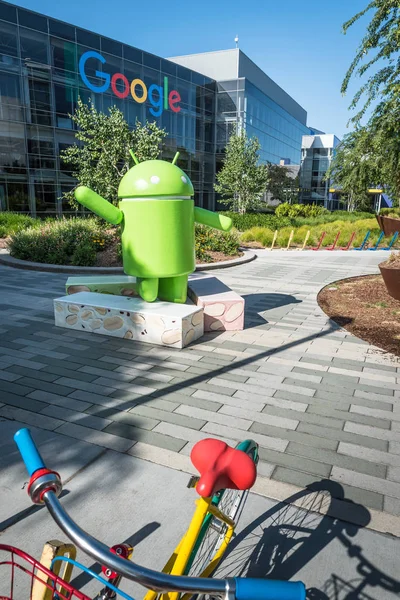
[0,429,306,600]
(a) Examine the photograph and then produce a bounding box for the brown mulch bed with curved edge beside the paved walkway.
[318,275,400,356]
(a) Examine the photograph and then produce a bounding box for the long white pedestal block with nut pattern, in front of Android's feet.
[54,292,204,348]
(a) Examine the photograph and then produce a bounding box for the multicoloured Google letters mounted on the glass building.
[79,50,181,117]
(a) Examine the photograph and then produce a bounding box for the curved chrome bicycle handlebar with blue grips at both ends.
[14,429,306,600]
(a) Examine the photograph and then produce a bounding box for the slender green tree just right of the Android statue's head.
[214,131,268,214]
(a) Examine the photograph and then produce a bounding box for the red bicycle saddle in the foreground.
[190,438,257,498]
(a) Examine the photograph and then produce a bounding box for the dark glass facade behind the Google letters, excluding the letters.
[0,1,216,216]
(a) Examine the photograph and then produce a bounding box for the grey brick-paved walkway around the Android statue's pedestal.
[0,251,400,515]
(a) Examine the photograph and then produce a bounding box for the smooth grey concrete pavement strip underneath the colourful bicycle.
[0,421,400,600]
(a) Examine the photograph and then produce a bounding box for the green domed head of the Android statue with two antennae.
[118,151,194,200]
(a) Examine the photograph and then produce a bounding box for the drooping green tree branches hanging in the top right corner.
[340,0,400,206]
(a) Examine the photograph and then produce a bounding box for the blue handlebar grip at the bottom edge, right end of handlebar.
[236,578,306,600]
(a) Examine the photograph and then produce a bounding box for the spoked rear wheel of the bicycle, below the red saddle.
[185,440,258,577]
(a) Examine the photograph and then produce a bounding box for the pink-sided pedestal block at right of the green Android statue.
[188,275,244,331]
